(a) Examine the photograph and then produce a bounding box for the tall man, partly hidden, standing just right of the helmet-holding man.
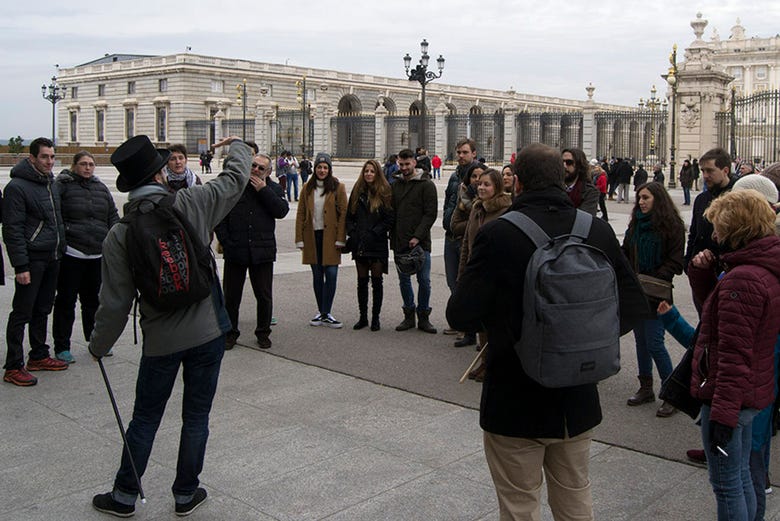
[442,138,477,335]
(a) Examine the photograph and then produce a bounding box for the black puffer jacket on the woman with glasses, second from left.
[55,169,119,255]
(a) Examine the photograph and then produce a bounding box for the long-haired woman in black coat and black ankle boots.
[347,159,393,331]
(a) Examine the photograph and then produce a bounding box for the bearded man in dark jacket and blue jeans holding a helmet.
[390,148,439,333]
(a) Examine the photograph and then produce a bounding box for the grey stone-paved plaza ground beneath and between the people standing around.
[0,163,780,521]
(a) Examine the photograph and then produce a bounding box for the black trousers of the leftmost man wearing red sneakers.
[3,260,60,369]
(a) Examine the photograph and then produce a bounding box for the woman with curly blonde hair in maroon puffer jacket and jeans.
[688,189,780,521]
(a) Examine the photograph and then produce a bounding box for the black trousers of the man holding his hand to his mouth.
[222,261,274,339]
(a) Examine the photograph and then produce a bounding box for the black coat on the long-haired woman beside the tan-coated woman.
[347,192,394,263]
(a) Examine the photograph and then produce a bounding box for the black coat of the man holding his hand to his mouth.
[214,177,290,266]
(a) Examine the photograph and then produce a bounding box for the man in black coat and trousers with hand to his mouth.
[214,154,290,349]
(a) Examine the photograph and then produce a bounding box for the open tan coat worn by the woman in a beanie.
[295,183,347,266]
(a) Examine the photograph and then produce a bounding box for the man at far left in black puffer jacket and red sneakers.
[3,137,68,386]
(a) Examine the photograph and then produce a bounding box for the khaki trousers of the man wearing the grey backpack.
[483,430,593,521]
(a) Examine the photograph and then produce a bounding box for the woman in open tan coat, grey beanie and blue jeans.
[295,152,347,329]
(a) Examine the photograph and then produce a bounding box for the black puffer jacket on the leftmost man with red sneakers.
[3,159,65,273]
